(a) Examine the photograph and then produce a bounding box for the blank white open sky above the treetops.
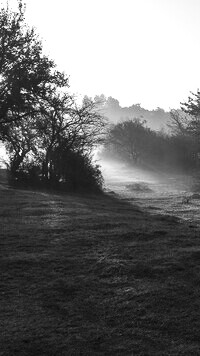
[1,0,200,110]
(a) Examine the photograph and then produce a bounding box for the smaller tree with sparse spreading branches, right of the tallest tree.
[31,94,106,181]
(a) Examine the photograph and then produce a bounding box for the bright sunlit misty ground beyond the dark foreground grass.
[98,159,200,223]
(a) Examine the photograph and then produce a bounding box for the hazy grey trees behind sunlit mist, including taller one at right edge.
[102,91,200,171]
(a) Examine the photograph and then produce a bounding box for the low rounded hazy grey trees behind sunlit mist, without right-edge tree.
[104,119,198,169]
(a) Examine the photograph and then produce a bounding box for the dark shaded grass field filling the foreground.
[0,182,200,356]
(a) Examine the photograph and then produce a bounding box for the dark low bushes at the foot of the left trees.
[10,147,103,192]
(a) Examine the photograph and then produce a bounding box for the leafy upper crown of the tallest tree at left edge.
[0,0,68,131]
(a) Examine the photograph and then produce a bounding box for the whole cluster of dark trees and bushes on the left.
[0,0,106,190]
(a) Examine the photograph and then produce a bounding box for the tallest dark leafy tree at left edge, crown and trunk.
[0,0,71,176]
